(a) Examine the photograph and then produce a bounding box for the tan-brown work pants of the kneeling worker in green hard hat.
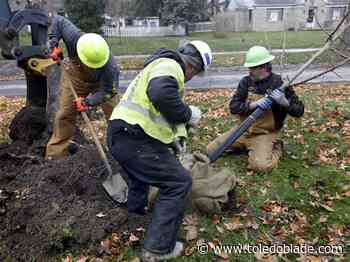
[207,126,282,172]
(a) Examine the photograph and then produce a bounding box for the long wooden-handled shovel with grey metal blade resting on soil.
[69,85,128,203]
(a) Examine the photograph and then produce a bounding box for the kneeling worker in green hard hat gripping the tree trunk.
[207,46,304,172]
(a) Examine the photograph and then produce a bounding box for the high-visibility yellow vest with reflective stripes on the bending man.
[110,58,187,144]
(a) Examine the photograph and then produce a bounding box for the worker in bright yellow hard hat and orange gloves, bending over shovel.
[46,16,119,158]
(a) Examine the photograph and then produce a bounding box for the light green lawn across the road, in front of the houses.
[107,31,327,55]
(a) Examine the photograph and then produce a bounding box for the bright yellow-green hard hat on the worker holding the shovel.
[77,33,110,69]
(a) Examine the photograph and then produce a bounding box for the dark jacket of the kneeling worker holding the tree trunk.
[230,73,304,130]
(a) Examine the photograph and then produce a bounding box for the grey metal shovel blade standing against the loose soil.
[102,173,128,204]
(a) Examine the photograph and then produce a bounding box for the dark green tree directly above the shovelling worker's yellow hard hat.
[64,0,105,33]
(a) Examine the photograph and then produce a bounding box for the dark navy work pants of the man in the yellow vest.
[107,120,192,254]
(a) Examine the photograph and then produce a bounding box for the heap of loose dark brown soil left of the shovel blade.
[0,106,149,261]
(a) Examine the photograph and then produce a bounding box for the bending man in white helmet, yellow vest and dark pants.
[108,41,213,261]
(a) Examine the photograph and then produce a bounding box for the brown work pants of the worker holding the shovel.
[45,60,117,158]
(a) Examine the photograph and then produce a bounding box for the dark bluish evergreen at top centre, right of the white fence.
[161,0,209,25]
